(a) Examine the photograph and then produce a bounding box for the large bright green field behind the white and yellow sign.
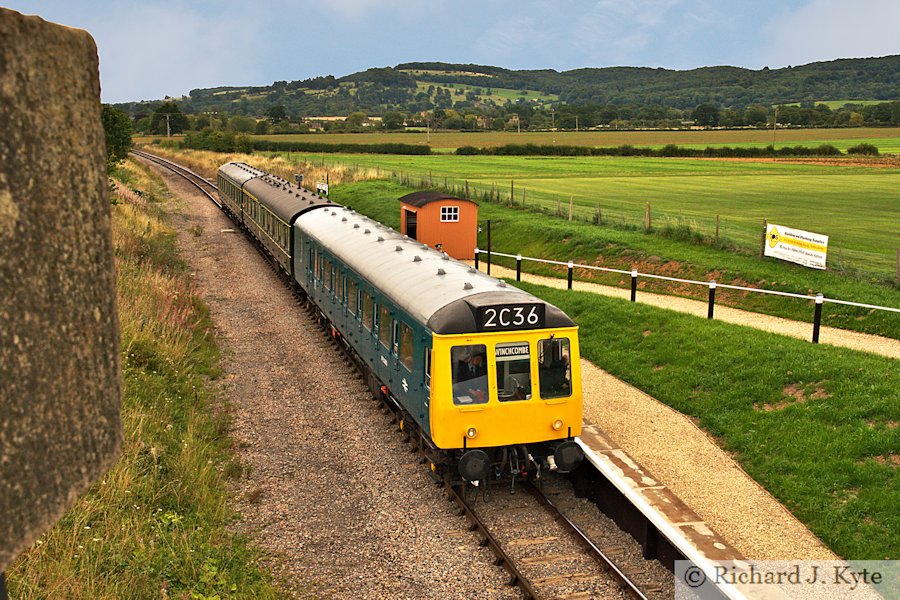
[292,155,900,276]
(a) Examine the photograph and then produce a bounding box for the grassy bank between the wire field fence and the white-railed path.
[331,181,900,338]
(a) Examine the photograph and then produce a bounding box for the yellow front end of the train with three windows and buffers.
[430,318,583,481]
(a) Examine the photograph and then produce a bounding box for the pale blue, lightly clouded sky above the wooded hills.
[7,0,900,103]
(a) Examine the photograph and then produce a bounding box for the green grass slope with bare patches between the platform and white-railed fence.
[511,282,900,560]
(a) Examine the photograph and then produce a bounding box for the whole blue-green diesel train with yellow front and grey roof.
[217,162,583,485]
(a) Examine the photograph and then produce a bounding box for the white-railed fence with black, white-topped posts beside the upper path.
[475,248,900,344]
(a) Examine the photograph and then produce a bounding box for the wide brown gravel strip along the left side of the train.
[147,162,519,598]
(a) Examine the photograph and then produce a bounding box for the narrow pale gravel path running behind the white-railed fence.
[479,264,900,359]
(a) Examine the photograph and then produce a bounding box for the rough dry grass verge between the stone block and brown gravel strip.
[8,159,282,599]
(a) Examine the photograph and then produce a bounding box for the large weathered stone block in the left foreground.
[0,8,122,571]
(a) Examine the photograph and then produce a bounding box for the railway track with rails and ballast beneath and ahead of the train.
[132,151,692,600]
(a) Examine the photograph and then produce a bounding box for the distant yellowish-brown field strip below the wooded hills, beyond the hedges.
[254,127,900,154]
